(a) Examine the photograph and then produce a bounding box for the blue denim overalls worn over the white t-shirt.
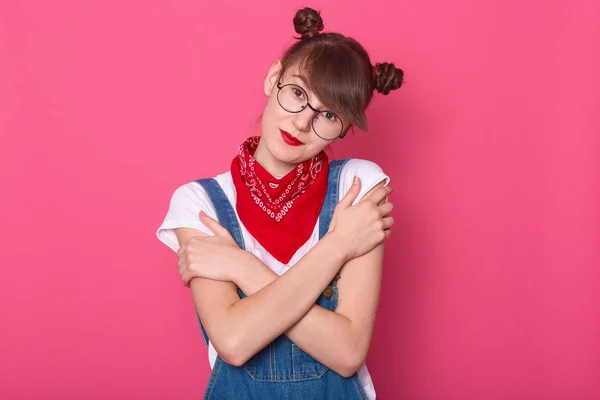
[196,159,367,400]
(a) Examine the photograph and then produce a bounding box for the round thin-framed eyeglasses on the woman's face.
[277,82,346,140]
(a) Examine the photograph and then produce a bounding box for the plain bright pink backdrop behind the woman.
[0,0,600,400]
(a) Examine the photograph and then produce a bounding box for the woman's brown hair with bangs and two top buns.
[282,8,404,130]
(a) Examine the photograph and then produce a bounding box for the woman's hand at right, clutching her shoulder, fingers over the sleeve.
[328,177,394,260]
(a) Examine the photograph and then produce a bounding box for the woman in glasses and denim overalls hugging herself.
[158,8,403,399]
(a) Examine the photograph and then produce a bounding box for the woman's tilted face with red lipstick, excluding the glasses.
[261,61,346,165]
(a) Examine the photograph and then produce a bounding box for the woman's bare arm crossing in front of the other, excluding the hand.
[176,228,346,365]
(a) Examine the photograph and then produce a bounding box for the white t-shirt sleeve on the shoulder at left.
[156,182,216,251]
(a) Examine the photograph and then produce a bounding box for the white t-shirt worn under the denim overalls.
[156,159,390,400]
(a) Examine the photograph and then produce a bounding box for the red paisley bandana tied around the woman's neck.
[231,136,329,264]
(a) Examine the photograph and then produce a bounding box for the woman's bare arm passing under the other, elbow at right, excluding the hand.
[227,182,384,376]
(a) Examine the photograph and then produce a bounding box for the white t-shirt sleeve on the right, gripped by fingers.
[339,158,390,204]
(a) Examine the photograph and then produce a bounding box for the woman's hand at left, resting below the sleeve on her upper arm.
[177,212,248,287]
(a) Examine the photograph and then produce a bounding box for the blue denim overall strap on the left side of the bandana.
[194,178,246,346]
